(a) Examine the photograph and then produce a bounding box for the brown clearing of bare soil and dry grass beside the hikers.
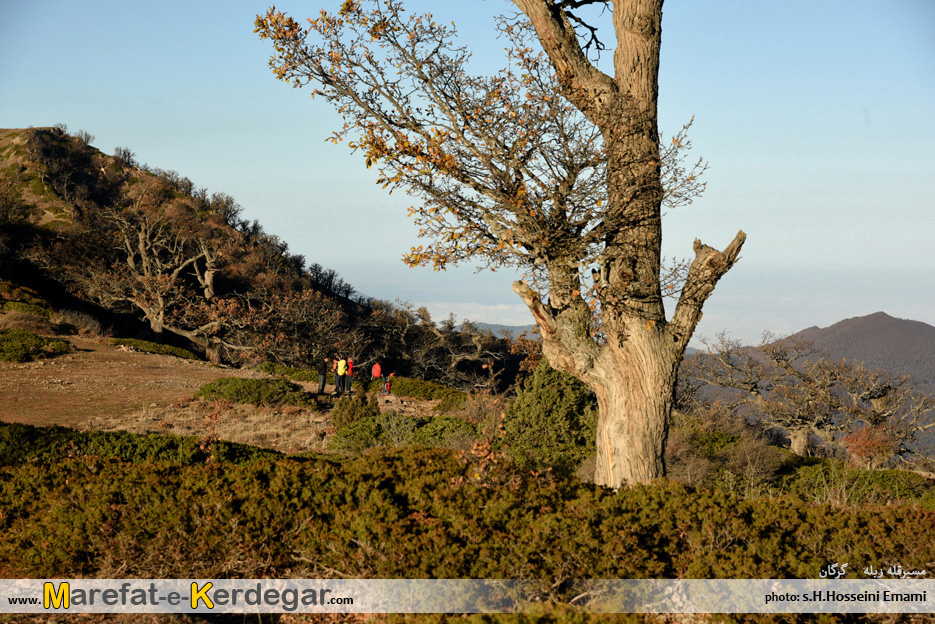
[0,336,464,453]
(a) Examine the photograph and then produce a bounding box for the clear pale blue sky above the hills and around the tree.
[0,0,935,344]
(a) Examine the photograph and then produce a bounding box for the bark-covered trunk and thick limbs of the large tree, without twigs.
[514,0,746,488]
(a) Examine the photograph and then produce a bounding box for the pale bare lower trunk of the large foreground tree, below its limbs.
[588,330,677,488]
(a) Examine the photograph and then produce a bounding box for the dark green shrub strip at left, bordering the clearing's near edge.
[0,422,280,466]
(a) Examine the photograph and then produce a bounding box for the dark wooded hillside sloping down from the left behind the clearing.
[0,126,518,389]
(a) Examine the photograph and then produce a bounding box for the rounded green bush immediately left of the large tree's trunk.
[503,359,598,473]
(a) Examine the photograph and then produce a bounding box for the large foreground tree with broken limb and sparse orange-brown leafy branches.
[256,0,745,487]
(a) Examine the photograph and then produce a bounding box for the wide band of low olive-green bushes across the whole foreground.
[0,449,935,580]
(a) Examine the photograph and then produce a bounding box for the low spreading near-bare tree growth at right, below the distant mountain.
[683,333,935,467]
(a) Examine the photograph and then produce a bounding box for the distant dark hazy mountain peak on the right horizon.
[792,312,935,394]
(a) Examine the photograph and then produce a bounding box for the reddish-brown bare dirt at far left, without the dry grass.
[0,336,265,427]
